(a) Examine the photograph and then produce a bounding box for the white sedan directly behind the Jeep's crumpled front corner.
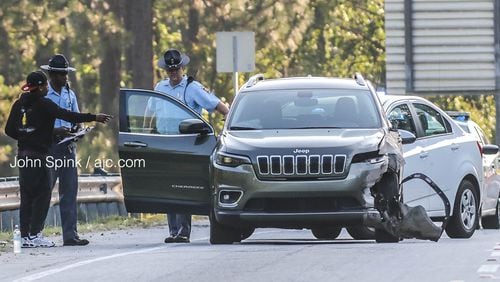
[379,95,484,238]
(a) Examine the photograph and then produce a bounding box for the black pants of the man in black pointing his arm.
[18,157,52,237]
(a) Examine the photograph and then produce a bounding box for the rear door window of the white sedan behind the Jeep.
[413,103,451,136]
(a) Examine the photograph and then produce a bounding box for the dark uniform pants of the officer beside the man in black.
[50,143,78,241]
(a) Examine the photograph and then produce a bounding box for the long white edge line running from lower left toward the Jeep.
[13,231,290,282]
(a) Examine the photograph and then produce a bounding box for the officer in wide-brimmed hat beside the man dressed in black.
[40,54,89,246]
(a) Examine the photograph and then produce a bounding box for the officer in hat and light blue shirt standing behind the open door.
[153,49,229,243]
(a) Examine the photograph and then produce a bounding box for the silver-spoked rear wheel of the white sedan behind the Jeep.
[446,179,479,238]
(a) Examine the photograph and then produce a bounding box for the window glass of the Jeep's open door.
[125,92,199,135]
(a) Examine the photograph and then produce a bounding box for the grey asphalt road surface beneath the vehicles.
[0,221,500,282]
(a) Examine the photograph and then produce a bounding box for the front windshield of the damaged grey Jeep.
[228,89,381,130]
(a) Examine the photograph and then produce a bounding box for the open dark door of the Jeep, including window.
[118,89,217,215]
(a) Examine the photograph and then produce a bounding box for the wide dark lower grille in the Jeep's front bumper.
[243,197,362,213]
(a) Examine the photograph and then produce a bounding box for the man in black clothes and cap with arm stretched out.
[5,71,112,248]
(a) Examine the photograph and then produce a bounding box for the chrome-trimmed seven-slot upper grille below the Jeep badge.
[257,155,347,176]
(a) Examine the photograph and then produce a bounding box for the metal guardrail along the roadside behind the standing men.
[0,174,123,212]
